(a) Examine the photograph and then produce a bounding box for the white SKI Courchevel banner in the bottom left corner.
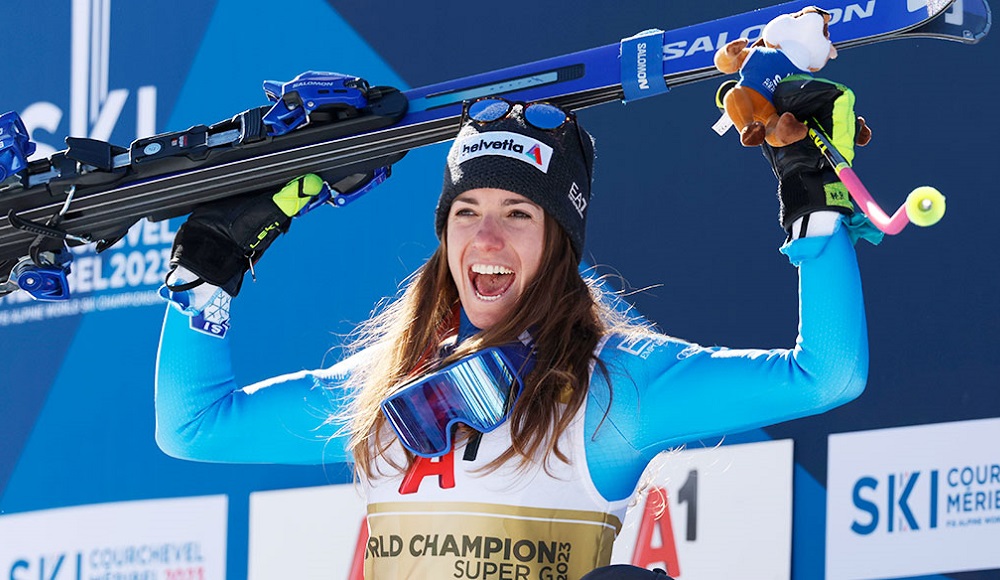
[0,496,228,580]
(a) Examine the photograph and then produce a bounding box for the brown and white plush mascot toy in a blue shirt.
[715,6,837,147]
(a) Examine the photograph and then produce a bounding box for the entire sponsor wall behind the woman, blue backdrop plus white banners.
[0,0,1000,580]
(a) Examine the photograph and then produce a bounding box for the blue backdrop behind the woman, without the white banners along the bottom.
[0,0,1000,578]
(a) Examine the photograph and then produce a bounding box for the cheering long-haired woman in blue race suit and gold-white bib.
[157,100,867,579]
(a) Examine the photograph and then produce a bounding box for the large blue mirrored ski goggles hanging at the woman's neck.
[382,347,530,457]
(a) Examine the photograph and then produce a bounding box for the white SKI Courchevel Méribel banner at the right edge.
[826,419,1000,580]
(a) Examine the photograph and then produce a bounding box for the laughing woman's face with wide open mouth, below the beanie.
[446,189,545,330]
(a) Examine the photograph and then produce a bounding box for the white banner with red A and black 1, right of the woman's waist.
[612,439,794,580]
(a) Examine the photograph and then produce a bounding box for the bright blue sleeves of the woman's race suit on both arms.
[156,227,868,500]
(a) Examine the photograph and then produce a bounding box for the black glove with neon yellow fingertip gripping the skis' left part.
[166,174,329,296]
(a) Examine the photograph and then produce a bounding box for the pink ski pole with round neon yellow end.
[807,124,945,235]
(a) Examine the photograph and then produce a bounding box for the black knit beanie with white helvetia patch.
[435,106,594,262]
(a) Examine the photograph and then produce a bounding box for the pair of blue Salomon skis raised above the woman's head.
[0,0,990,299]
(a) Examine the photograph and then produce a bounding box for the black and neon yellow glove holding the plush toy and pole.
[763,77,871,232]
